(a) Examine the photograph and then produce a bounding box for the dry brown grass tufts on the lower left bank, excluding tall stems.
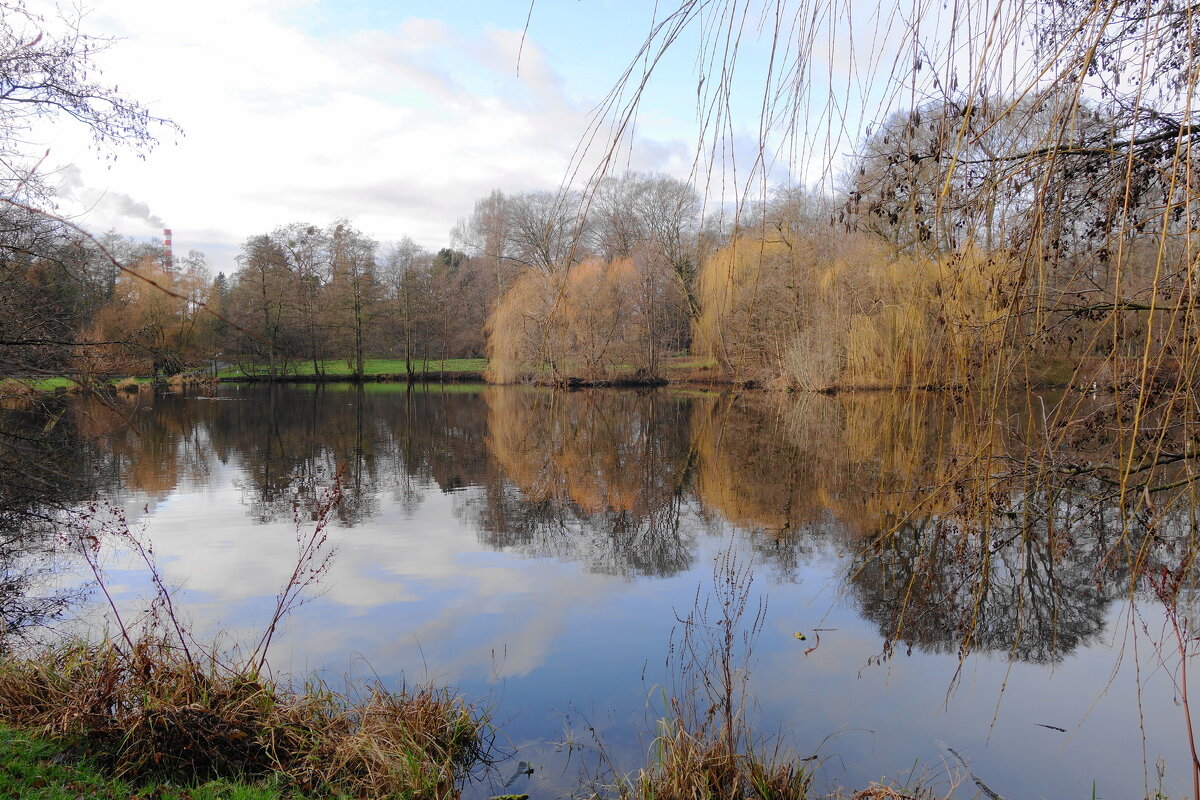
[0,639,488,798]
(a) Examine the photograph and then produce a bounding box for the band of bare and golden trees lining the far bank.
[0,95,1195,390]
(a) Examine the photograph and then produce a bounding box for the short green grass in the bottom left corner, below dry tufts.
[0,726,288,800]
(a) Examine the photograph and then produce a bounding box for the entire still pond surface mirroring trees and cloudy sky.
[21,385,1190,798]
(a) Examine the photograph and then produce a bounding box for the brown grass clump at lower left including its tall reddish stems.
[0,484,492,800]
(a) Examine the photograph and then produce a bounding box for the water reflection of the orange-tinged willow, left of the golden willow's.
[465,386,695,576]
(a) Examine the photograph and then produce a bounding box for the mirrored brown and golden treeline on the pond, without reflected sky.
[14,385,1192,663]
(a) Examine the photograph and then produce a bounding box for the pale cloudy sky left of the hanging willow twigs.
[25,0,710,271]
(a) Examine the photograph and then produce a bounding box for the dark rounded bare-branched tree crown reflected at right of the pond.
[848,498,1128,663]
